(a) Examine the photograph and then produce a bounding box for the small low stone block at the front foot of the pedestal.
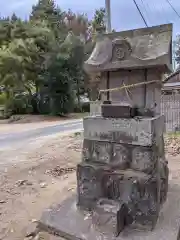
[92,199,132,237]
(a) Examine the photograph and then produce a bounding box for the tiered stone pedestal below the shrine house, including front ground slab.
[40,113,169,240]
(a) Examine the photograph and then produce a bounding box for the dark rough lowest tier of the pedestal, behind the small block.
[77,158,161,228]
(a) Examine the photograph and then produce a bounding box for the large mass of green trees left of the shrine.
[0,0,105,115]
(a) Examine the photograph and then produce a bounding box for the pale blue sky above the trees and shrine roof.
[0,0,180,37]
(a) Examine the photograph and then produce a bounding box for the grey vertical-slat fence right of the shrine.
[161,93,180,132]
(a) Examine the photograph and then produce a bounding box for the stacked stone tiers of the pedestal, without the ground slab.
[77,116,168,233]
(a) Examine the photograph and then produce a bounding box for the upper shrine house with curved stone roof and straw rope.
[88,24,172,115]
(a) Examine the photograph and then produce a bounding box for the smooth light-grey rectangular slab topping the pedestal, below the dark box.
[83,116,165,146]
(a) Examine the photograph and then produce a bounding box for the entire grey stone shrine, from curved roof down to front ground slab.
[41,24,172,240]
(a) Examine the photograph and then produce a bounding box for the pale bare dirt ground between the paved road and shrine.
[0,133,81,240]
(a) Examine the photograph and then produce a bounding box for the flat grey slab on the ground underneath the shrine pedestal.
[39,191,180,240]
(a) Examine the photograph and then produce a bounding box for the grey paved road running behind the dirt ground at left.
[0,120,83,149]
